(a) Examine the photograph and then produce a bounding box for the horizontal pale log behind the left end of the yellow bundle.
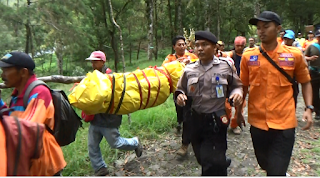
[0,75,86,88]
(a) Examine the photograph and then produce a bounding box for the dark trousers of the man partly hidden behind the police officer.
[175,104,191,145]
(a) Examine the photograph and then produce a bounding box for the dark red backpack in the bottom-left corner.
[0,108,45,176]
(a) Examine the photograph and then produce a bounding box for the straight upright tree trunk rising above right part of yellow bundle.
[146,0,154,60]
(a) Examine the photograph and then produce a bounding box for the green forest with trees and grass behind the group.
[0,0,320,175]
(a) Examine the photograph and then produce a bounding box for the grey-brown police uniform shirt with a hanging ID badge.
[177,56,243,113]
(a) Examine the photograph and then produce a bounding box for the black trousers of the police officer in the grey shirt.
[190,111,229,176]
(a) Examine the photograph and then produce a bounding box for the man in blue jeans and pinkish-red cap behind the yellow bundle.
[81,51,142,176]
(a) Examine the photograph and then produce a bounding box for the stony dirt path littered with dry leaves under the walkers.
[113,95,320,176]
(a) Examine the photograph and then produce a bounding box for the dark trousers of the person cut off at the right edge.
[309,70,320,115]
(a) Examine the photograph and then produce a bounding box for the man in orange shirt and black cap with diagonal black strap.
[237,11,313,176]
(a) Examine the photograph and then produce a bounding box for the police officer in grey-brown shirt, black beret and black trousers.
[175,31,243,176]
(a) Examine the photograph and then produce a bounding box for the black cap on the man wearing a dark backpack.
[0,52,35,70]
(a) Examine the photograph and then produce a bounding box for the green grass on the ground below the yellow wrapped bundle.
[63,95,176,176]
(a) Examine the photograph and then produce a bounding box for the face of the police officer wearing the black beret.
[195,40,217,62]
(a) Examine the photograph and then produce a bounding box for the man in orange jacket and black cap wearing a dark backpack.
[0,52,67,176]
